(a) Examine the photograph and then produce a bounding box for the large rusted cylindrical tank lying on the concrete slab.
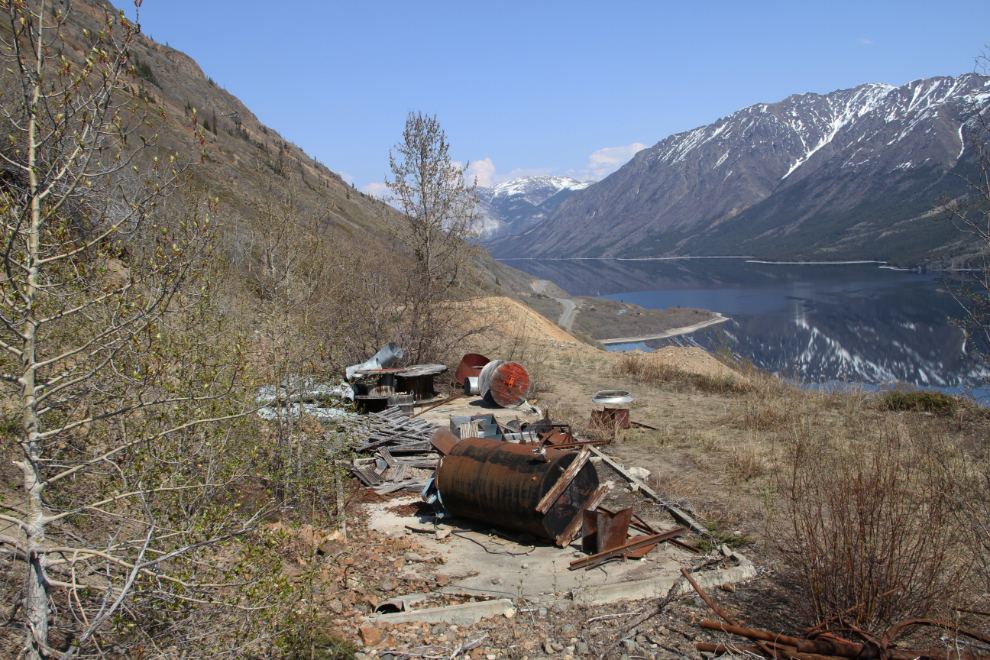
[436,438,599,540]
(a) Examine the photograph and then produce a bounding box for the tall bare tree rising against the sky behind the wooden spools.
[385,112,478,361]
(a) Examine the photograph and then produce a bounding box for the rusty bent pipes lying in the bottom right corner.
[681,569,990,660]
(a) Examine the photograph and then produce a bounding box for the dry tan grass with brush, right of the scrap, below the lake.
[592,352,990,631]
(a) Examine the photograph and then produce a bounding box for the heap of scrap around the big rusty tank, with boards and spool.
[347,345,698,570]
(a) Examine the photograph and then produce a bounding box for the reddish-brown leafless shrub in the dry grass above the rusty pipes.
[766,421,960,630]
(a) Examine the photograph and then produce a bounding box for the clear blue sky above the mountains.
[124,0,990,192]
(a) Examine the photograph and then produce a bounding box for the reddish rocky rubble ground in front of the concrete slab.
[291,493,800,660]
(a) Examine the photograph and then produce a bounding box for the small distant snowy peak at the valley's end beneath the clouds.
[475,176,591,239]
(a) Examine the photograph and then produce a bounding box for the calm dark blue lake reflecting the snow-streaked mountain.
[506,259,986,398]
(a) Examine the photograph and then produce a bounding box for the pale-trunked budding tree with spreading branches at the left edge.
[0,0,264,660]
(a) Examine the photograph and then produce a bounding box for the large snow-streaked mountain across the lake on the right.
[491,74,990,263]
